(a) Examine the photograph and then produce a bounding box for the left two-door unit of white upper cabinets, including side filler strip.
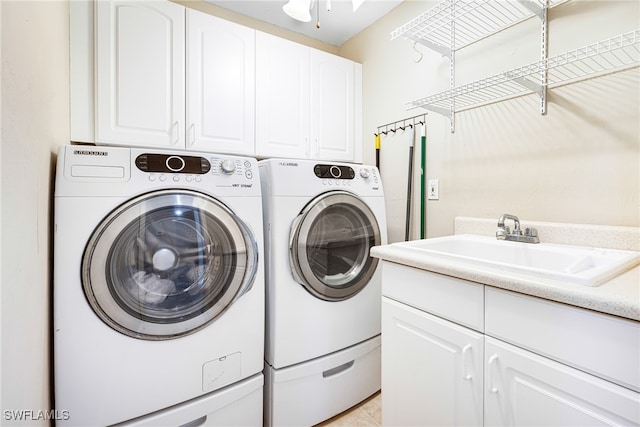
[75,0,255,155]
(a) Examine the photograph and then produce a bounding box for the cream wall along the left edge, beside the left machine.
[0,0,69,426]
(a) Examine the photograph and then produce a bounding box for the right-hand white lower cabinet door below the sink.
[485,337,640,426]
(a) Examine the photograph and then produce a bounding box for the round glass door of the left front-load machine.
[82,191,258,340]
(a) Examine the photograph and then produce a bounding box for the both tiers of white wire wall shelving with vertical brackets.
[391,0,640,133]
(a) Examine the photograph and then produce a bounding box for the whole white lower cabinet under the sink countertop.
[382,261,640,426]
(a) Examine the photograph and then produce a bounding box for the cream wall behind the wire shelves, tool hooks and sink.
[339,0,640,238]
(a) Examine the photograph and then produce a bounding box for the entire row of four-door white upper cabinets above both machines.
[69,0,362,163]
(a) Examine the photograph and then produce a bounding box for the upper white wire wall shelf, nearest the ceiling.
[391,0,567,57]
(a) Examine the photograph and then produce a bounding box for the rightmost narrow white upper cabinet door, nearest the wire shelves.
[311,49,355,162]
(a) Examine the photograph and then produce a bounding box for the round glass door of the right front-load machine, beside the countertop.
[289,191,380,301]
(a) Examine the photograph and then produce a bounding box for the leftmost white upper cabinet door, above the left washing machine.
[95,0,185,148]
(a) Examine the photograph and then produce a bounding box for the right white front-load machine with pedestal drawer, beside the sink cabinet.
[258,159,386,426]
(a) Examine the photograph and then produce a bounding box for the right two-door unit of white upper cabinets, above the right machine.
[256,32,362,162]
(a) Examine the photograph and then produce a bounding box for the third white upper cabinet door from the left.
[256,32,309,158]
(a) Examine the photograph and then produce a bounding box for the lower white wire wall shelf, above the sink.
[407,29,640,115]
